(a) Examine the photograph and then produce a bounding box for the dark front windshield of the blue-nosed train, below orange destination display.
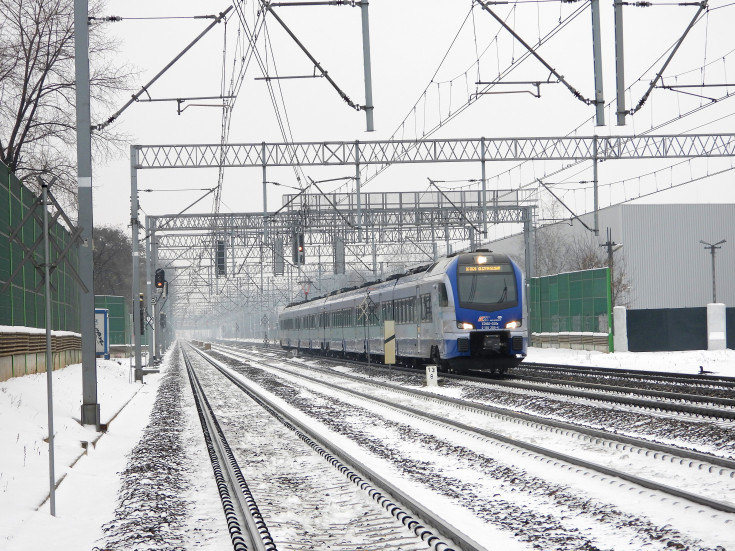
[457,264,518,312]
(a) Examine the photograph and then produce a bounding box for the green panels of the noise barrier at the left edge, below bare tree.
[0,163,79,332]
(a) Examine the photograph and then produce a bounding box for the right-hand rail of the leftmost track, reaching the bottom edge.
[188,348,489,551]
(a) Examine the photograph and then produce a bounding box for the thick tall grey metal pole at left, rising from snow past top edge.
[74,0,100,430]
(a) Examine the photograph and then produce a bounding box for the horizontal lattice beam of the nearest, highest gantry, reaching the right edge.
[133,134,735,169]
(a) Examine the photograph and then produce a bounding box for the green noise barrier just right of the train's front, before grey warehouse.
[530,268,613,351]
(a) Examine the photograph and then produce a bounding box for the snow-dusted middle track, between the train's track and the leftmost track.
[211,340,735,513]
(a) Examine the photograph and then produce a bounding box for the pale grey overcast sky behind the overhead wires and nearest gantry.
[93,0,735,237]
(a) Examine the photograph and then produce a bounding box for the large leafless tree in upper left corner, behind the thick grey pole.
[0,0,131,215]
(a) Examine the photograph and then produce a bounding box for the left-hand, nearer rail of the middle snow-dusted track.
[210,344,735,513]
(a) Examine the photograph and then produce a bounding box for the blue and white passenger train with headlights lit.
[278,249,528,374]
